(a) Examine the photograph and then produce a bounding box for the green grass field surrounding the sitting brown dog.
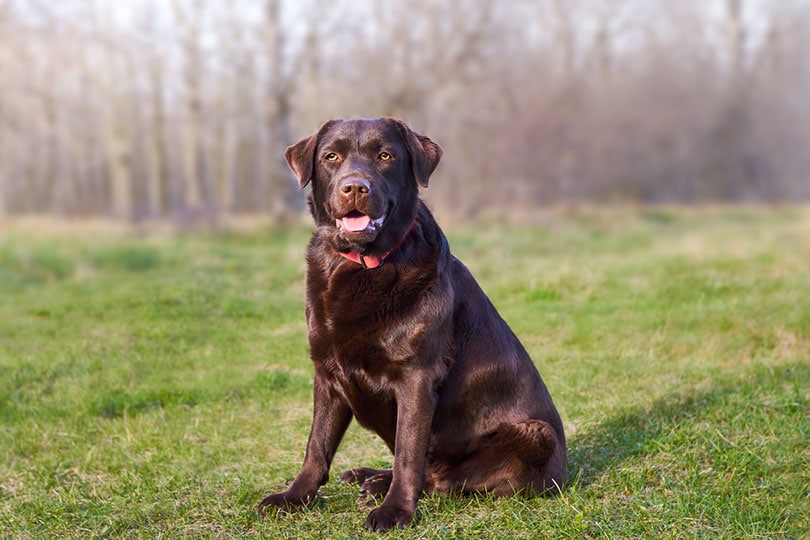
[0,208,810,538]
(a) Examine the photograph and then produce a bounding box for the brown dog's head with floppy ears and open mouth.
[284,118,442,253]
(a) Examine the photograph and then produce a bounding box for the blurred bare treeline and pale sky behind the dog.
[0,0,810,220]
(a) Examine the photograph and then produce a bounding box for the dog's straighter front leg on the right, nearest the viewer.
[366,373,437,532]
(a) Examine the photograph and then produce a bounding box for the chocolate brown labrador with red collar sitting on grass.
[259,118,566,531]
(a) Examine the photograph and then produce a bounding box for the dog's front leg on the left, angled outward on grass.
[258,369,352,513]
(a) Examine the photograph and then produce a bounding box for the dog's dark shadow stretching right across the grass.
[568,363,810,487]
